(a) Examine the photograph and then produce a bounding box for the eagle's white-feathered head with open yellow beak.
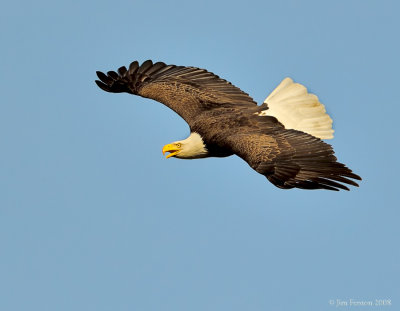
[162,132,208,159]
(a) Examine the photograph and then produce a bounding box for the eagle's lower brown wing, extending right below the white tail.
[228,128,361,190]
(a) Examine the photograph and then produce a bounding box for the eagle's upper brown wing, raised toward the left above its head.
[96,60,256,125]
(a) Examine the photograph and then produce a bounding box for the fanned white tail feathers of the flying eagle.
[259,78,333,139]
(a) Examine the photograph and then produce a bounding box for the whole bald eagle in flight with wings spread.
[96,60,361,191]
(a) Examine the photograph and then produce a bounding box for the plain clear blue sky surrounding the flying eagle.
[0,0,400,311]
